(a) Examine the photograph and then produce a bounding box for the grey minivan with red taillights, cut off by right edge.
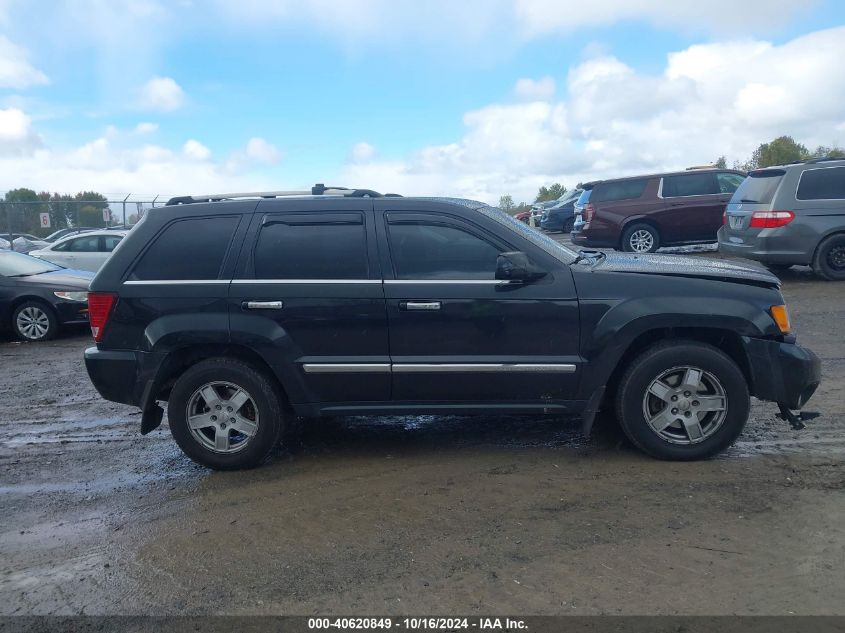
[719,159,845,281]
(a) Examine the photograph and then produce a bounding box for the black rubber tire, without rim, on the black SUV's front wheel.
[616,340,751,461]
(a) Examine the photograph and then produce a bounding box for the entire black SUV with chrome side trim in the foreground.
[85,186,819,469]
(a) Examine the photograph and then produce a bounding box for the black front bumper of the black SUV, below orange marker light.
[742,336,821,409]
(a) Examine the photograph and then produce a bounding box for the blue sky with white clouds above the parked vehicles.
[0,0,845,203]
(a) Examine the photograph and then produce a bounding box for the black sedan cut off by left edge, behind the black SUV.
[0,251,94,341]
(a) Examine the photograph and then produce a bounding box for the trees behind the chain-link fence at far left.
[0,188,111,236]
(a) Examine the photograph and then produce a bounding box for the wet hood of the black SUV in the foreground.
[592,253,780,286]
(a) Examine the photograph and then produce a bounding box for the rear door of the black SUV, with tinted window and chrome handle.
[230,199,390,403]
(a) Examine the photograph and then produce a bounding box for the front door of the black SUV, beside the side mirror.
[375,201,579,407]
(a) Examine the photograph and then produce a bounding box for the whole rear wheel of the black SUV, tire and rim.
[167,358,284,470]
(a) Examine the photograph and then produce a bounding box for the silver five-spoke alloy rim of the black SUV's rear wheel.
[187,382,258,453]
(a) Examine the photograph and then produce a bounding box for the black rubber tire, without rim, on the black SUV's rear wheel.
[167,357,284,470]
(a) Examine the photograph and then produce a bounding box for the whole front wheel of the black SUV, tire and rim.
[616,340,750,461]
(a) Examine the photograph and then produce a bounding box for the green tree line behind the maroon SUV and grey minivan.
[499,136,845,214]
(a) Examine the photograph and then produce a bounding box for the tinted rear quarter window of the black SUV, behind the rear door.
[129,216,240,281]
